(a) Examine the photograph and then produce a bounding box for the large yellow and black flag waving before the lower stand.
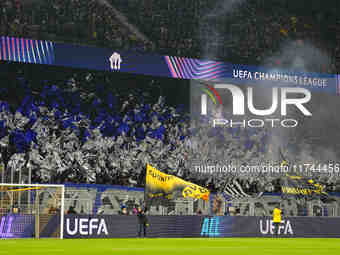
[145,164,210,200]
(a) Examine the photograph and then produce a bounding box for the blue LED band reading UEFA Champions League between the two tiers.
[0,36,338,94]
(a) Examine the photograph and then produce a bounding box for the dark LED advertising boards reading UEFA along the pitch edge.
[0,215,340,238]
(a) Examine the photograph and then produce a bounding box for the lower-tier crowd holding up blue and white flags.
[0,62,337,194]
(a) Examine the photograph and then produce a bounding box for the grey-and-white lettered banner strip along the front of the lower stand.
[0,181,340,217]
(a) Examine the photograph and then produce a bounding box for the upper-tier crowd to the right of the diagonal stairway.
[111,0,339,73]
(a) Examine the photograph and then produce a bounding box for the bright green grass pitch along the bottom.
[0,238,340,255]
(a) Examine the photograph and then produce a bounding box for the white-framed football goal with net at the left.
[0,183,65,239]
